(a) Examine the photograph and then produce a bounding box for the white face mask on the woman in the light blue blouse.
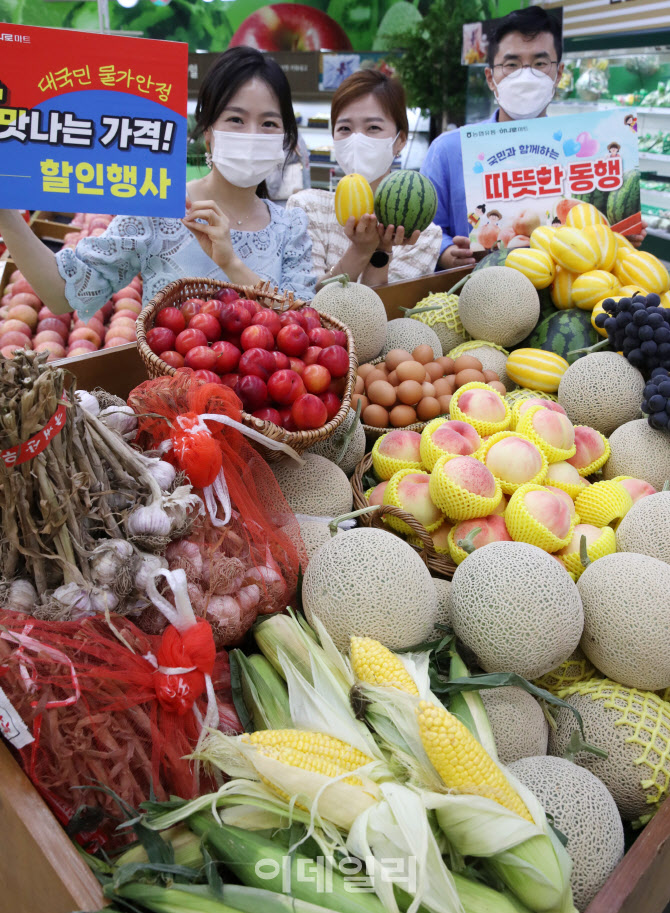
[212,130,286,187]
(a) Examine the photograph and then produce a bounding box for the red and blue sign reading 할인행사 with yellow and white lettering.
[0,24,188,217]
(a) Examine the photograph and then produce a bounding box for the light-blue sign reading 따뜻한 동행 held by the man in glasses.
[460,108,641,251]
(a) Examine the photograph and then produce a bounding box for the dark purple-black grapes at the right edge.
[595,292,670,430]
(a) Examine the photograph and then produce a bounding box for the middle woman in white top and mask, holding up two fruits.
[286,70,441,285]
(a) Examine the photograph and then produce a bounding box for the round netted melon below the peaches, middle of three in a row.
[451,542,584,679]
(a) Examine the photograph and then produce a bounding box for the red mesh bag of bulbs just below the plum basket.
[128,371,306,645]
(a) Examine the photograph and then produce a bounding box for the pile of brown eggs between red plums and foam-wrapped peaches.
[351,345,507,437]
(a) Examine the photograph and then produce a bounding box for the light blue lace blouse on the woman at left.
[56,200,316,320]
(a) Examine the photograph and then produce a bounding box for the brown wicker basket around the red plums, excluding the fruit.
[136,278,358,462]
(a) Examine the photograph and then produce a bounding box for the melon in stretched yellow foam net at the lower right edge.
[549,676,670,821]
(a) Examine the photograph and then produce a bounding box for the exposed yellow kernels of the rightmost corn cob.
[417,701,532,821]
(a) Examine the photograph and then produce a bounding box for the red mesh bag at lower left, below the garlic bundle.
[0,610,241,847]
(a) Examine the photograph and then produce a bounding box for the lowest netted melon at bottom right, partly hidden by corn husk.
[510,756,624,910]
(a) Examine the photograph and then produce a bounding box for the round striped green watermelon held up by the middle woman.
[375,170,437,238]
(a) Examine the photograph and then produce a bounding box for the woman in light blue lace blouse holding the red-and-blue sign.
[0,47,316,320]
